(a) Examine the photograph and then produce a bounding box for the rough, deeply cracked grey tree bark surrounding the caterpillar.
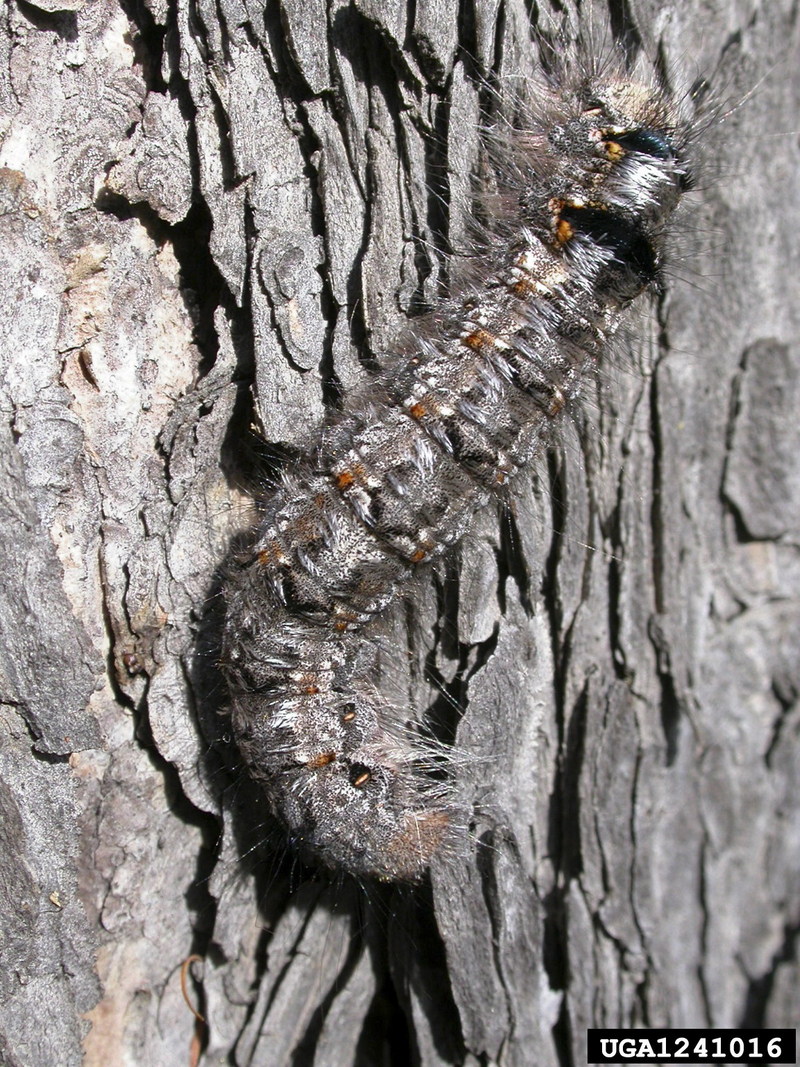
[0,0,800,1067]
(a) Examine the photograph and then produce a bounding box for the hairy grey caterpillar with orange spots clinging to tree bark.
[221,41,691,881]
